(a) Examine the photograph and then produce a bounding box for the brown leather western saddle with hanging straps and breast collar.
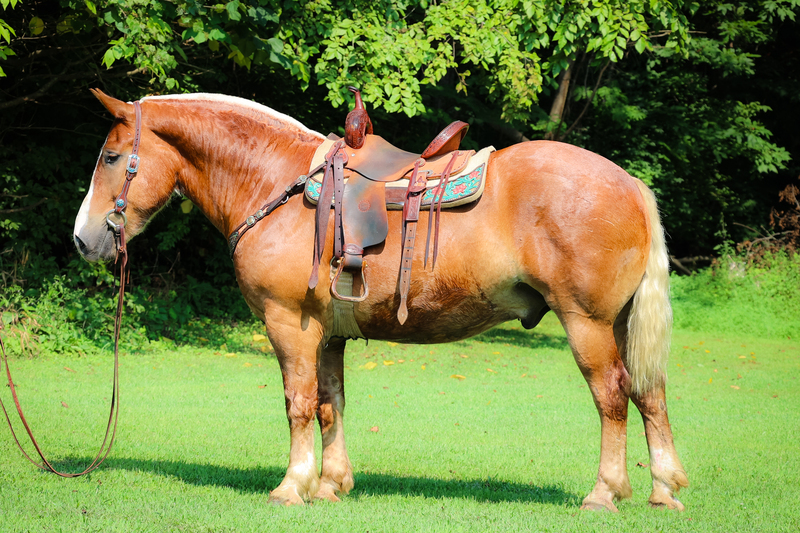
[228,87,475,324]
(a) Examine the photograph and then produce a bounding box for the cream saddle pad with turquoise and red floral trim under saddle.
[305,141,495,210]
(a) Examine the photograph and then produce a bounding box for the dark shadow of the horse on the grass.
[56,458,582,507]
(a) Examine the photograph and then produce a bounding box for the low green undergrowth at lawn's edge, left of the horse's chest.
[0,261,260,357]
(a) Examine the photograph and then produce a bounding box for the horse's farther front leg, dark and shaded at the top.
[315,337,353,501]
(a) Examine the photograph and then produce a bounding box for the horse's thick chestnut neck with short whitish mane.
[150,99,323,236]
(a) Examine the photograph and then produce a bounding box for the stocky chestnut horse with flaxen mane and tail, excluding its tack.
[74,91,688,511]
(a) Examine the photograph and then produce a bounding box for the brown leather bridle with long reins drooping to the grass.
[0,101,142,478]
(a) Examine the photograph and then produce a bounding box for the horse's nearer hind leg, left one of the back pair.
[559,313,632,511]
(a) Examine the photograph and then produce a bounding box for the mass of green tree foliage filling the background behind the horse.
[0,0,800,308]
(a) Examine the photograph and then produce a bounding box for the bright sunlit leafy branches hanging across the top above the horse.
[0,0,696,116]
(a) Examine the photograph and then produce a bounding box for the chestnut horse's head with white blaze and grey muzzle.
[73,89,179,261]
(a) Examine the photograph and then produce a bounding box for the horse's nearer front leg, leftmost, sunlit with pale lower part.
[267,310,322,505]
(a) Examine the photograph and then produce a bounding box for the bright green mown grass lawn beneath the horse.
[0,314,800,532]
